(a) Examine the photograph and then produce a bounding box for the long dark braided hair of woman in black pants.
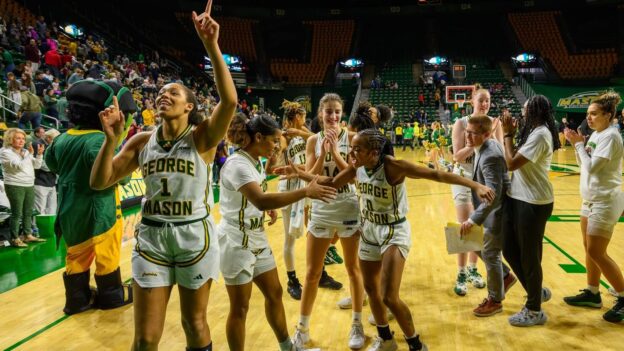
[517,95,561,151]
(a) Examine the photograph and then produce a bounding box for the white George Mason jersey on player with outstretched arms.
[356,162,407,224]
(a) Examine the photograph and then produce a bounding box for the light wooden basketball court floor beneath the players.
[0,147,624,351]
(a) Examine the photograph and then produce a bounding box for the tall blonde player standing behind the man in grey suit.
[451,85,516,296]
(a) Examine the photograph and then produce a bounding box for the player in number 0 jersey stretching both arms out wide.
[276,129,494,351]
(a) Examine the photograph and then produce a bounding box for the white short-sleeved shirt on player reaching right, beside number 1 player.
[219,150,268,249]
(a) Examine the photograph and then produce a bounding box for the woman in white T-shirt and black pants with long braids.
[503,95,561,327]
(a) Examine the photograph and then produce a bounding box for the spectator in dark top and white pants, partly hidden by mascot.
[33,127,61,215]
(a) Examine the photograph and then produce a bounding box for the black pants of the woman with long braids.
[503,195,553,311]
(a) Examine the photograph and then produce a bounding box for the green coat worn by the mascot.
[44,129,121,247]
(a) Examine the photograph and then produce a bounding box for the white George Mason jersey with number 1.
[139,126,211,222]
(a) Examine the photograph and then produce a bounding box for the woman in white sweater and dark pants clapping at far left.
[0,128,45,248]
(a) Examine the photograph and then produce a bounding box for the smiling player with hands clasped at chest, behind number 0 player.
[294,93,366,349]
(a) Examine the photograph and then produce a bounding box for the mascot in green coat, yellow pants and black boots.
[45,80,137,314]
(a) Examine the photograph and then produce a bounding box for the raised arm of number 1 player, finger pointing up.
[193,0,238,153]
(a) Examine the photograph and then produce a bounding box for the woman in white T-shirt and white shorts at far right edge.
[564,91,624,323]
